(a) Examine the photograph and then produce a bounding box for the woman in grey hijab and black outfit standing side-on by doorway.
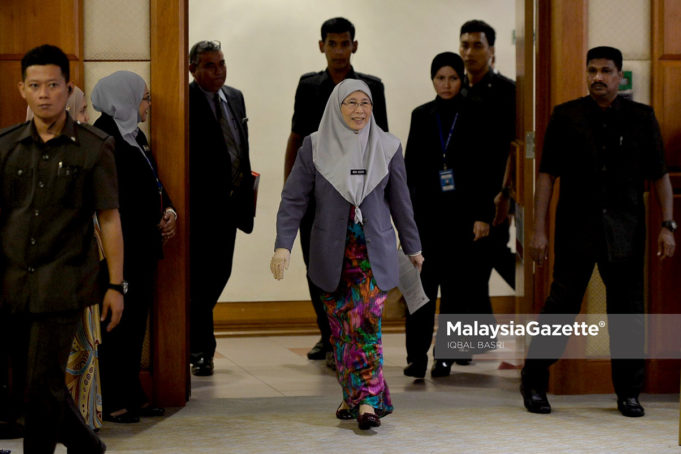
[92,71,177,423]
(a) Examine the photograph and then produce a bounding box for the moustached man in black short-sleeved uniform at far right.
[521,47,676,417]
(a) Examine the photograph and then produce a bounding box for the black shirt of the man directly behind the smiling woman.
[291,68,388,137]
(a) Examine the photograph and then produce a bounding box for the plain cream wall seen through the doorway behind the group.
[189,0,515,301]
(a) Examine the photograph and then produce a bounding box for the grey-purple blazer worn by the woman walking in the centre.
[274,136,421,292]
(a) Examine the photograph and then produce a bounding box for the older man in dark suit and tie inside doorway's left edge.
[189,41,255,376]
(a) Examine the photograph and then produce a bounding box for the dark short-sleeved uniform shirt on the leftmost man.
[0,115,118,313]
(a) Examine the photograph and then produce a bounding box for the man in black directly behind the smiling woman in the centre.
[284,17,388,367]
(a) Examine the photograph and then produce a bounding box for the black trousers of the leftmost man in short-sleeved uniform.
[0,309,99,454]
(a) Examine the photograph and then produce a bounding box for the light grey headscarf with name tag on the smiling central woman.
[310,79,400,223]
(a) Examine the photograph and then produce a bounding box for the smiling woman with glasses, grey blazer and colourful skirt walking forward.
[270,79,423,430]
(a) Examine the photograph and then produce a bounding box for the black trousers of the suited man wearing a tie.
[189,220,236,359]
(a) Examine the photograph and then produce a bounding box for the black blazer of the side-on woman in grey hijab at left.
[94,114,173,262]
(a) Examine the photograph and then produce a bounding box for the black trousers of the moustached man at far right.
[523,240,645,397]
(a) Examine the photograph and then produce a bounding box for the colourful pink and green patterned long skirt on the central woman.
[321,207,393,416]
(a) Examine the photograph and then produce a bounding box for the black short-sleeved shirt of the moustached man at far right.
[539,96,667,260]
